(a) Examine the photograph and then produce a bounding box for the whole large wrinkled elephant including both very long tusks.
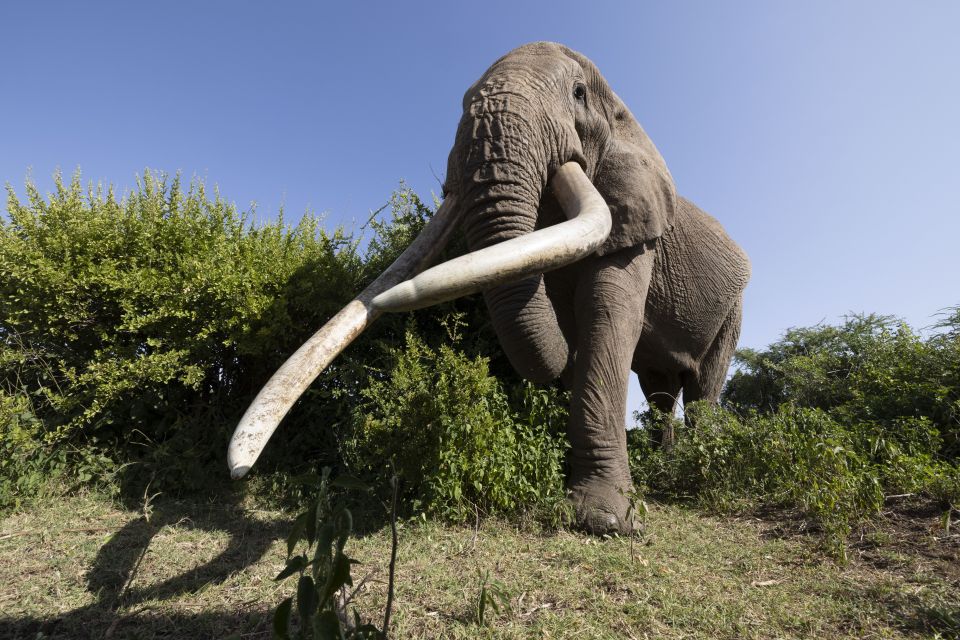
[228,42,750,534]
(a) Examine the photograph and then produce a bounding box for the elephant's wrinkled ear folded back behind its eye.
[593,101,677,255]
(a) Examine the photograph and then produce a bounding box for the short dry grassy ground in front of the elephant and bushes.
[0,496,960,638]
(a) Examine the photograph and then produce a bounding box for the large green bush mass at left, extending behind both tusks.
[0,172,532,509]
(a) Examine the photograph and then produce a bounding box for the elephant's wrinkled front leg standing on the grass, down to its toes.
[567,246,654,533]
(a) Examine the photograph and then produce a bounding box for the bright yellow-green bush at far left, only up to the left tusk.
[0,173,361,502]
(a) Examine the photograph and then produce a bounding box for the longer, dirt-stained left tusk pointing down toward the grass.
[227,197,461,478]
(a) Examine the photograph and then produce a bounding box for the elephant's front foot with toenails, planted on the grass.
[570,479,637,536]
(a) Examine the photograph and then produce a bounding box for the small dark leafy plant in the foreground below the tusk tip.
[273,467,388,640]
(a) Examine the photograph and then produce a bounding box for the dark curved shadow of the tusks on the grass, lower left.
[0,498,290,640]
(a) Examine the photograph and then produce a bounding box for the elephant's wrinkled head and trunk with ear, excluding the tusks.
[432,43,676,382]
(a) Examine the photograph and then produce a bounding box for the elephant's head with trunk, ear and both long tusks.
[229,43,704,529]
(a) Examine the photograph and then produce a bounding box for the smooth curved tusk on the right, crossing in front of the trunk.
[373,162,612,311]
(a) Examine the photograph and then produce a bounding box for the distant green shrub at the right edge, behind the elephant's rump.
[724,307,960,524]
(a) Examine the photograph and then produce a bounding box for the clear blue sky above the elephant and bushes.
[0,0,960,416]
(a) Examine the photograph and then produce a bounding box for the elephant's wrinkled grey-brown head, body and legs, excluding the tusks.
[444,43,750,533]
